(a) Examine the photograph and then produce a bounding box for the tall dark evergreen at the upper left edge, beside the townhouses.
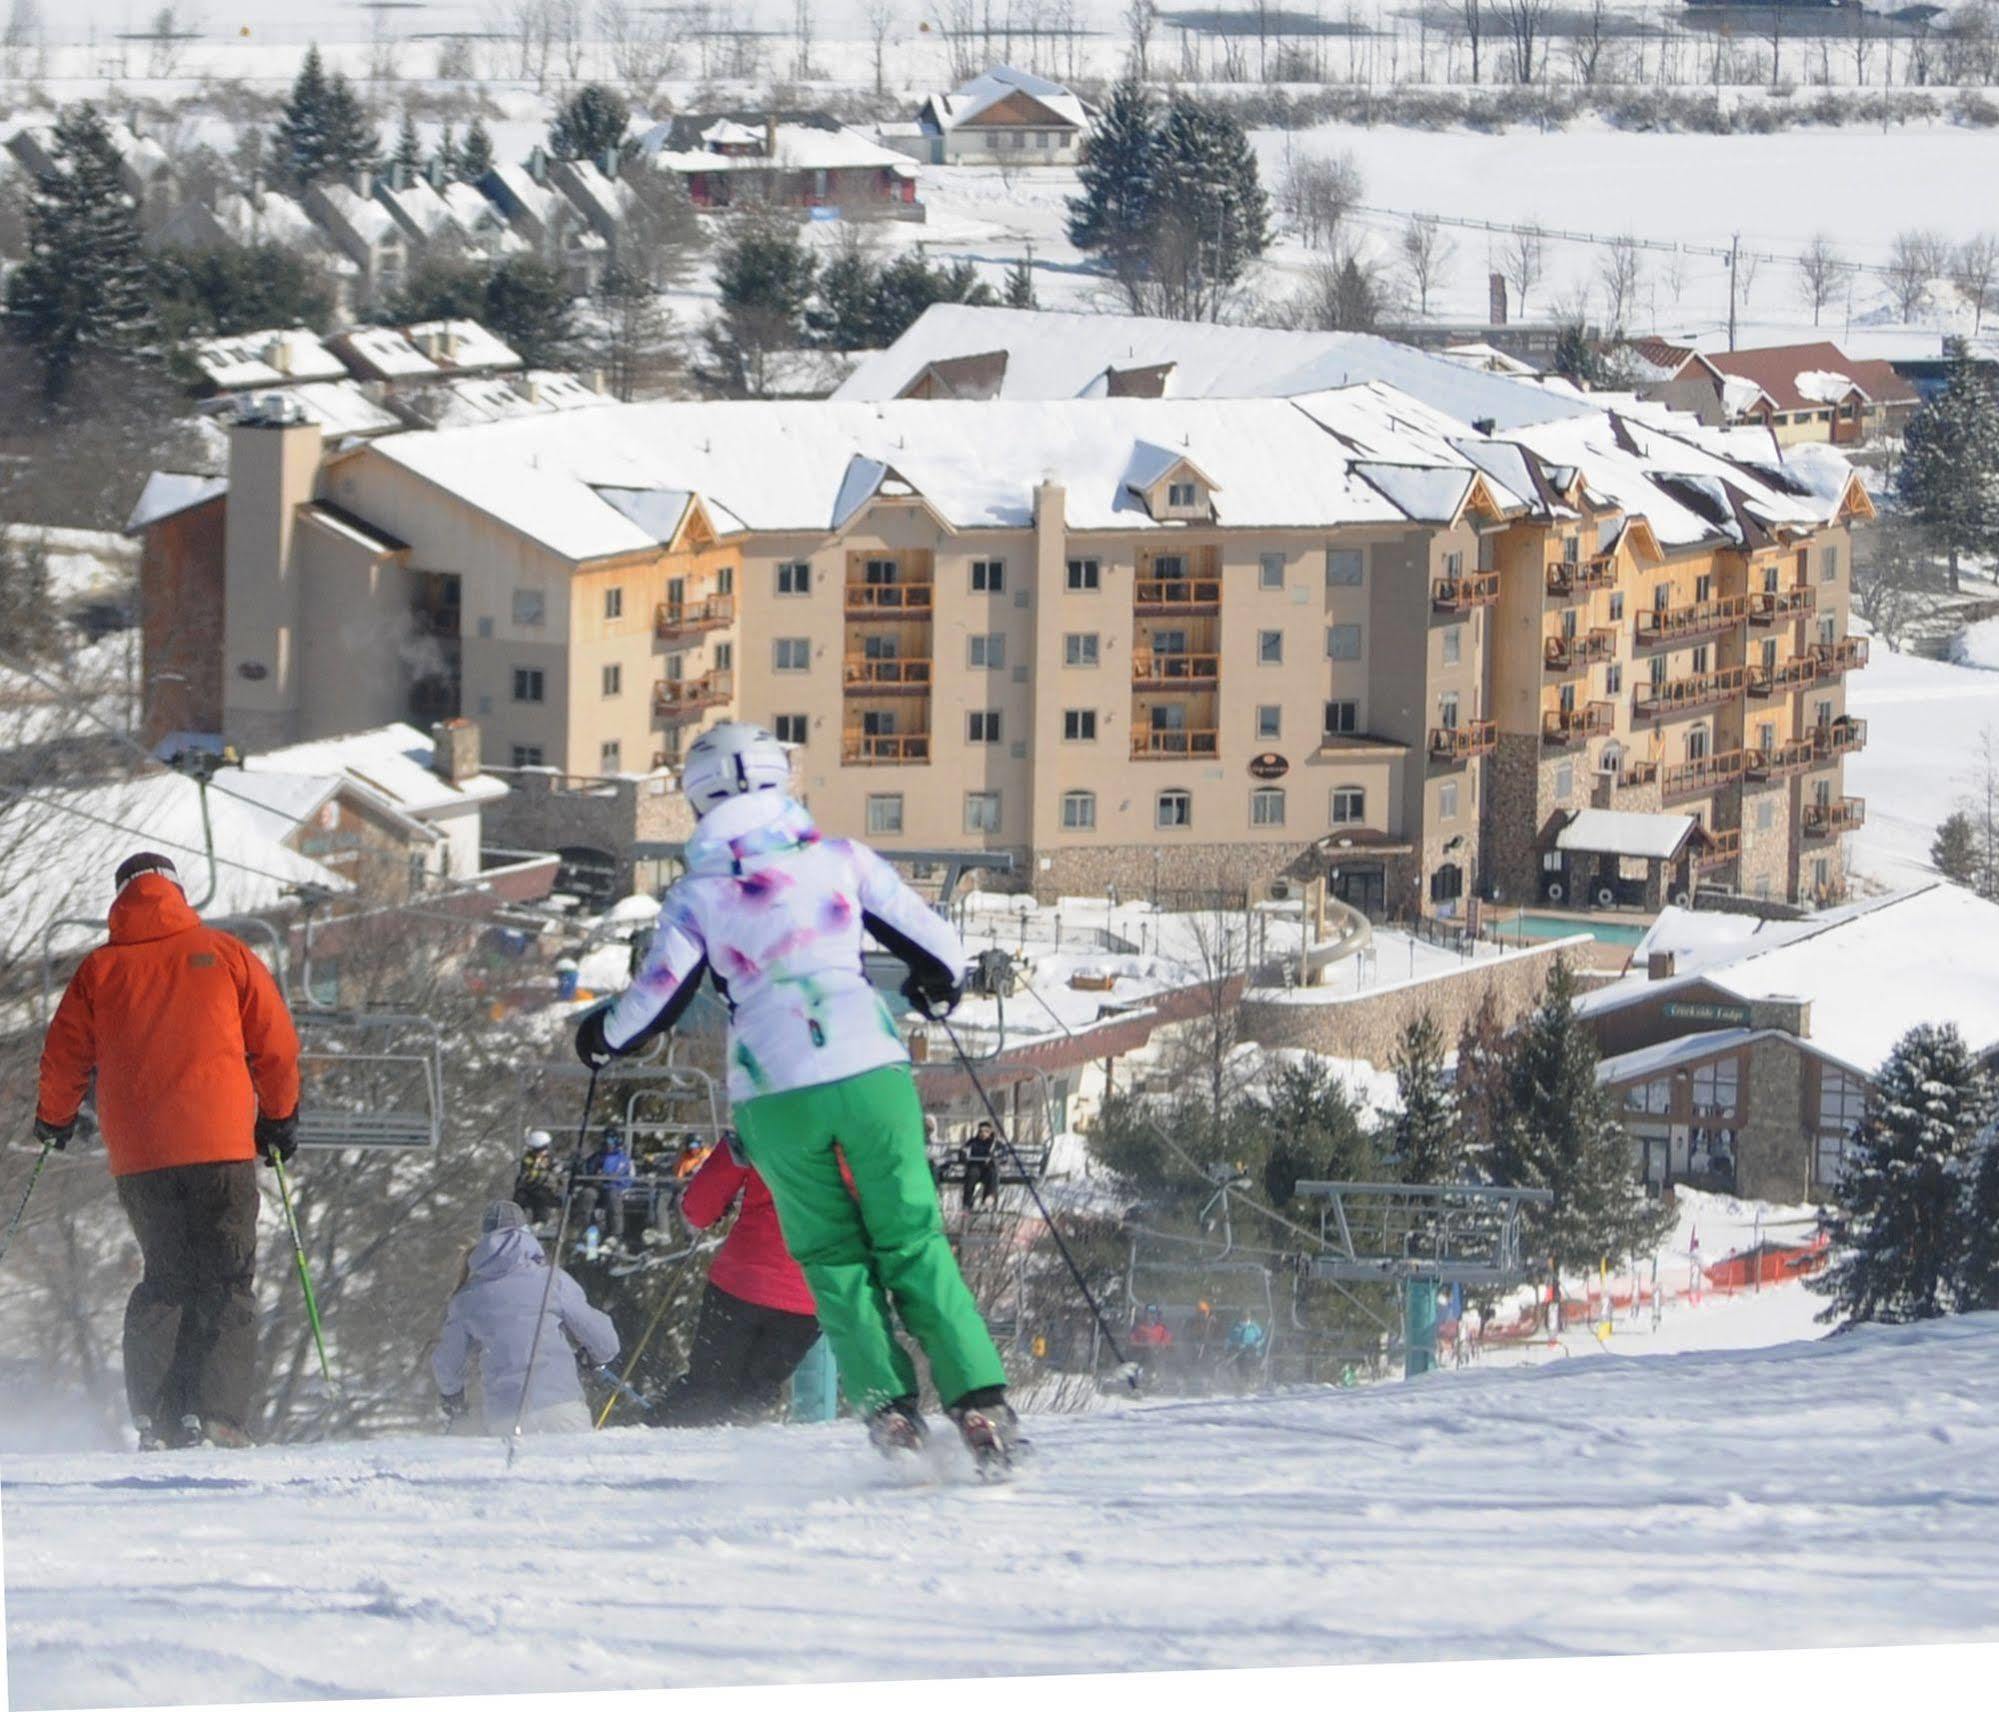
[6,102,156,398]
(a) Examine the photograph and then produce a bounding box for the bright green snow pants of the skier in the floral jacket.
[736,1064,1005,1412]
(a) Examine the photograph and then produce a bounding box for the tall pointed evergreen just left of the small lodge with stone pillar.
[1493,958,1671,1272]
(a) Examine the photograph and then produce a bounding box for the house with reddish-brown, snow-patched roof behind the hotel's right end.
[1631,338,1921,446]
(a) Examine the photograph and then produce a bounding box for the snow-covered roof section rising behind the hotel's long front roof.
[834,304,1599,430]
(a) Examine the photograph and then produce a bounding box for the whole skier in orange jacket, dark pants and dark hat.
[34,852,298,1450]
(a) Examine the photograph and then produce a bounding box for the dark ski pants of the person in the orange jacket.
[118,1160,258,1430]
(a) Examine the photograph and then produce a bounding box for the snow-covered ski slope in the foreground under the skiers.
[0,1316,1999,1706]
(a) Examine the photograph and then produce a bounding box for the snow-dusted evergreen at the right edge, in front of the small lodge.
[1811,1022,1991,1324]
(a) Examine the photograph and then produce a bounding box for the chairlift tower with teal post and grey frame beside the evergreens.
[1297,1182,1555,1378]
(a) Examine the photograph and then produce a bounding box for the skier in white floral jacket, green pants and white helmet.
[576,724,1019,1476]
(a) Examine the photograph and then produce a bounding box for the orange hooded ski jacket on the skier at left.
[36,874,298,1176]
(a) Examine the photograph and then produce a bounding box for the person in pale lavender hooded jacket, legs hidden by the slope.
[430,1200,618,1434]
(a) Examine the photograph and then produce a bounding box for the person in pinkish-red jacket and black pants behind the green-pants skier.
[652,1132,820,1426]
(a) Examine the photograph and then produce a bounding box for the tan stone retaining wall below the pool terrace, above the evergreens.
[1239,928,1573,1068]
